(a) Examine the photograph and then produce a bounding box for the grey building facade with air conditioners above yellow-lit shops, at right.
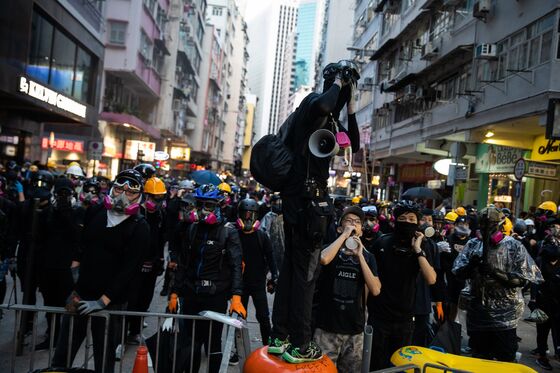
[366,0,560,211]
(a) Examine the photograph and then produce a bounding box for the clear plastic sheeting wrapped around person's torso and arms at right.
[452,236,544,331]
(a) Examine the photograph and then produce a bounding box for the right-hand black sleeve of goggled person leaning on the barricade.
[104,219,150,300]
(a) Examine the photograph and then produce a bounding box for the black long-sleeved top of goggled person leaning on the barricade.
[74,205,150,304]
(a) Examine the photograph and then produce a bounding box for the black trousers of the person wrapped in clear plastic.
[469,329,518,362]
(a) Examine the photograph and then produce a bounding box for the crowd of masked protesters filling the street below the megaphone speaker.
[0,158,560,372]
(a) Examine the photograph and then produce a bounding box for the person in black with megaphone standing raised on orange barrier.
[268,60,360,363]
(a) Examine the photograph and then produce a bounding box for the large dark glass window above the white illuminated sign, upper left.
[26,11,97,104]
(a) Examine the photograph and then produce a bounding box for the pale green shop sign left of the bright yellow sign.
[475,144,525,174]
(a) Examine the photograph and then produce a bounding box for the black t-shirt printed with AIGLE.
[317,250,377,335]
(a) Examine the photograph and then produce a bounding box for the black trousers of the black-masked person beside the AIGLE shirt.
[369,316,414,371]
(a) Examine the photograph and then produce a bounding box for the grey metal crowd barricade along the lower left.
[0,304,251,373]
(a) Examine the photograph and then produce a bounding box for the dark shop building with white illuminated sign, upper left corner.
[0,0,104,163]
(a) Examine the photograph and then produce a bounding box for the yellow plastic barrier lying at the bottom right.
[391,346,537,373]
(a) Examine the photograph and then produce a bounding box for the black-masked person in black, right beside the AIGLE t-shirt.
[367,200,437,370]
